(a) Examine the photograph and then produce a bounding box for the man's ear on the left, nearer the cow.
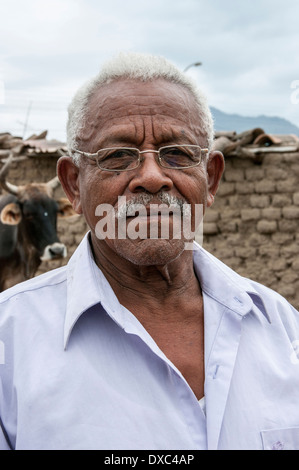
[57,156,82,214]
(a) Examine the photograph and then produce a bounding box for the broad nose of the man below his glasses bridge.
[129,150,174,194]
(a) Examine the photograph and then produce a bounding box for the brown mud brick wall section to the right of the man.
[203,152,299,309]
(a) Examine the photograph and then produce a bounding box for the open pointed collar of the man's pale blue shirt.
[64,232,270,348]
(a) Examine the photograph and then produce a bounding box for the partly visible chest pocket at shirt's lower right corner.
[261,427,299,450]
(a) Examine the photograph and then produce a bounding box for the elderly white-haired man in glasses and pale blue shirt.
[0,54,299,450]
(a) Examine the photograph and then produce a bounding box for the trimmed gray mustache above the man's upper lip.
[116,191,190,219]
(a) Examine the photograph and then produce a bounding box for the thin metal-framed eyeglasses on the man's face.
[72,145,209,171]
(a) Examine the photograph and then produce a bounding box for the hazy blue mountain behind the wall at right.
[211,107,299,137]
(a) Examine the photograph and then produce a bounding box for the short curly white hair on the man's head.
[67,52,214,164]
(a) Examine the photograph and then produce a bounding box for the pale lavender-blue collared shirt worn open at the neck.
[0,236,299,450]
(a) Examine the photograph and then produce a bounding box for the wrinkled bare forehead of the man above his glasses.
[79,79,207,147]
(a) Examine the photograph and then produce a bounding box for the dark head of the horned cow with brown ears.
[0,177,75,261]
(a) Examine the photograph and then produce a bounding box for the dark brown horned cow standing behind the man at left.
[0,156,75,292]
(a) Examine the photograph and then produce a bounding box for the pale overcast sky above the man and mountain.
[0,0,299,141]
